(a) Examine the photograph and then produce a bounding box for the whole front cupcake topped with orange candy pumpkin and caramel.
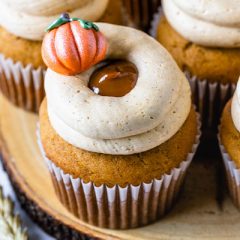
[38,16,200,229]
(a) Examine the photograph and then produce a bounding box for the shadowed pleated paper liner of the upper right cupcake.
[149,7,236,133]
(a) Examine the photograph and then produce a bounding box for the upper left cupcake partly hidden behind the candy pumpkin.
[0,0,123,112]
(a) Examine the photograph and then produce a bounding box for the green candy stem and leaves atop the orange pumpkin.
[46,13,99,32]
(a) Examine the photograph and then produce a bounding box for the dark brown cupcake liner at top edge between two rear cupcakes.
[122,0,161,32]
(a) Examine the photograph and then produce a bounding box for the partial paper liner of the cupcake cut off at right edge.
[218,134,240,210]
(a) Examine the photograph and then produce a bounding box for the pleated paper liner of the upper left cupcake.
[0,54,45,112]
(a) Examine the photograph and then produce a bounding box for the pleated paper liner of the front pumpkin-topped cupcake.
[37,112,201,229]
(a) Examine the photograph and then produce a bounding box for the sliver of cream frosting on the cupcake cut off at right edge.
[231,78,240,132]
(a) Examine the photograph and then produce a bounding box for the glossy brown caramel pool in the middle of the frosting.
[88,60,138,97]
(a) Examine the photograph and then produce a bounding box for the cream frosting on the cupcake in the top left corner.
[0,0,109,40]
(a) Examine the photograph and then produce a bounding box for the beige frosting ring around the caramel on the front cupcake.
[45,23,191,154]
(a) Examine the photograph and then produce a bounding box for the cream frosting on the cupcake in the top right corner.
[162,0,240,48]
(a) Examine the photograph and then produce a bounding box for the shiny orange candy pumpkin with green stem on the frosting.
[42,13,107,75]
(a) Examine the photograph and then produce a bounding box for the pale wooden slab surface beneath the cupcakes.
[0,96,240,240]
